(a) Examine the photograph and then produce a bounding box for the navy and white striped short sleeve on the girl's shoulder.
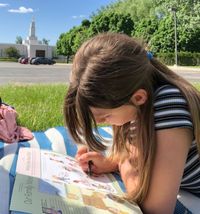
[154,85,193,130]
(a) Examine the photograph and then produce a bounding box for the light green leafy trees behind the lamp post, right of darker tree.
[102,0,200,52]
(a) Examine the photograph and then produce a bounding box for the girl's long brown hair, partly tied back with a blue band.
[64,33,200,203]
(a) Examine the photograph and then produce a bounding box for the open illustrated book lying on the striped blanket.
[10,148,142,214]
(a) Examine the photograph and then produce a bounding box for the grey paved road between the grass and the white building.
[0,62,200,85]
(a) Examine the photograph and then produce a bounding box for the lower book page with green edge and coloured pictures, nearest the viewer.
[10,174,141,214]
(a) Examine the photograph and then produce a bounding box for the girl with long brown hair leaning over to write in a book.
[64,33,200,214]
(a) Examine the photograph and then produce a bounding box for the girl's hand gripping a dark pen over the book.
[75,146,118,174]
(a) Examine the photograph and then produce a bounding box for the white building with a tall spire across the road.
[0,20,55,58]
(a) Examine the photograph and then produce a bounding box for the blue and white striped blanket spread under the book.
[0,124,200,214]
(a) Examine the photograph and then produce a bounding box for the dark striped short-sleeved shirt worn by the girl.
[154,85,200,196]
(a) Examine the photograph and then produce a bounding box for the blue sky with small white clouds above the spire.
[0,0,116,45]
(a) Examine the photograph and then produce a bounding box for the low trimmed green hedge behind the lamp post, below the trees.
[157,52,200,66]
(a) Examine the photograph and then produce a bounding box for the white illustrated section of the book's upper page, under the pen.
[41,151,117,193]
